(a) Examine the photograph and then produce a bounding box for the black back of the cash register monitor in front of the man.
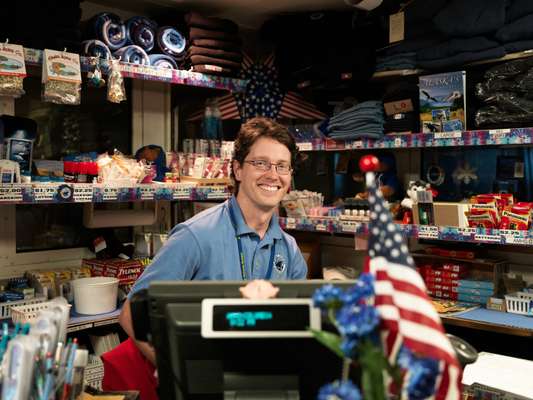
[139,281,354,400]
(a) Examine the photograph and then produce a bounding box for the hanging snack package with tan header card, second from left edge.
[42,49,81,105]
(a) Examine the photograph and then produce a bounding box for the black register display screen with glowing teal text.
[213,304,310,332]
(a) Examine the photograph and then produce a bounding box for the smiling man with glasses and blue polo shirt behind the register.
[120,118,307,362]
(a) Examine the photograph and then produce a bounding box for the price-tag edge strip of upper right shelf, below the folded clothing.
[297,128,533,151]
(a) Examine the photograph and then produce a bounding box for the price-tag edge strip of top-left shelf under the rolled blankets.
[24,48,248,92]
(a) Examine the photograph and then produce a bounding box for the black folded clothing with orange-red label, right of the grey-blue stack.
[383,81,420,133]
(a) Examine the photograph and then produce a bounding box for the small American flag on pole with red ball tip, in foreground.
[365,172,461,400]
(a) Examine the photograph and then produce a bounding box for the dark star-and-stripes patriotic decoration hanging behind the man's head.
[189,54,326,121]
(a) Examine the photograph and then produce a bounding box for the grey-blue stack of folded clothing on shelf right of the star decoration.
[319,100,384,140]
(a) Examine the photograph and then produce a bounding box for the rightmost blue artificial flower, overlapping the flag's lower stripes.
[407,357,439,400]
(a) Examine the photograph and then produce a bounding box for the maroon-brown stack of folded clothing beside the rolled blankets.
[185,12,242,76]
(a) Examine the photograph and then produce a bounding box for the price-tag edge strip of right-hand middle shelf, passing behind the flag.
[280,218,533,246]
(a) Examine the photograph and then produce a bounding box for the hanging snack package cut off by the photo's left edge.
[0,42,26,98]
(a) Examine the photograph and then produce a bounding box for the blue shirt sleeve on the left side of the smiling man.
[128,225,201,297]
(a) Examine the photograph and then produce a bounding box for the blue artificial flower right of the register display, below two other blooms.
[337,304,379,338]
